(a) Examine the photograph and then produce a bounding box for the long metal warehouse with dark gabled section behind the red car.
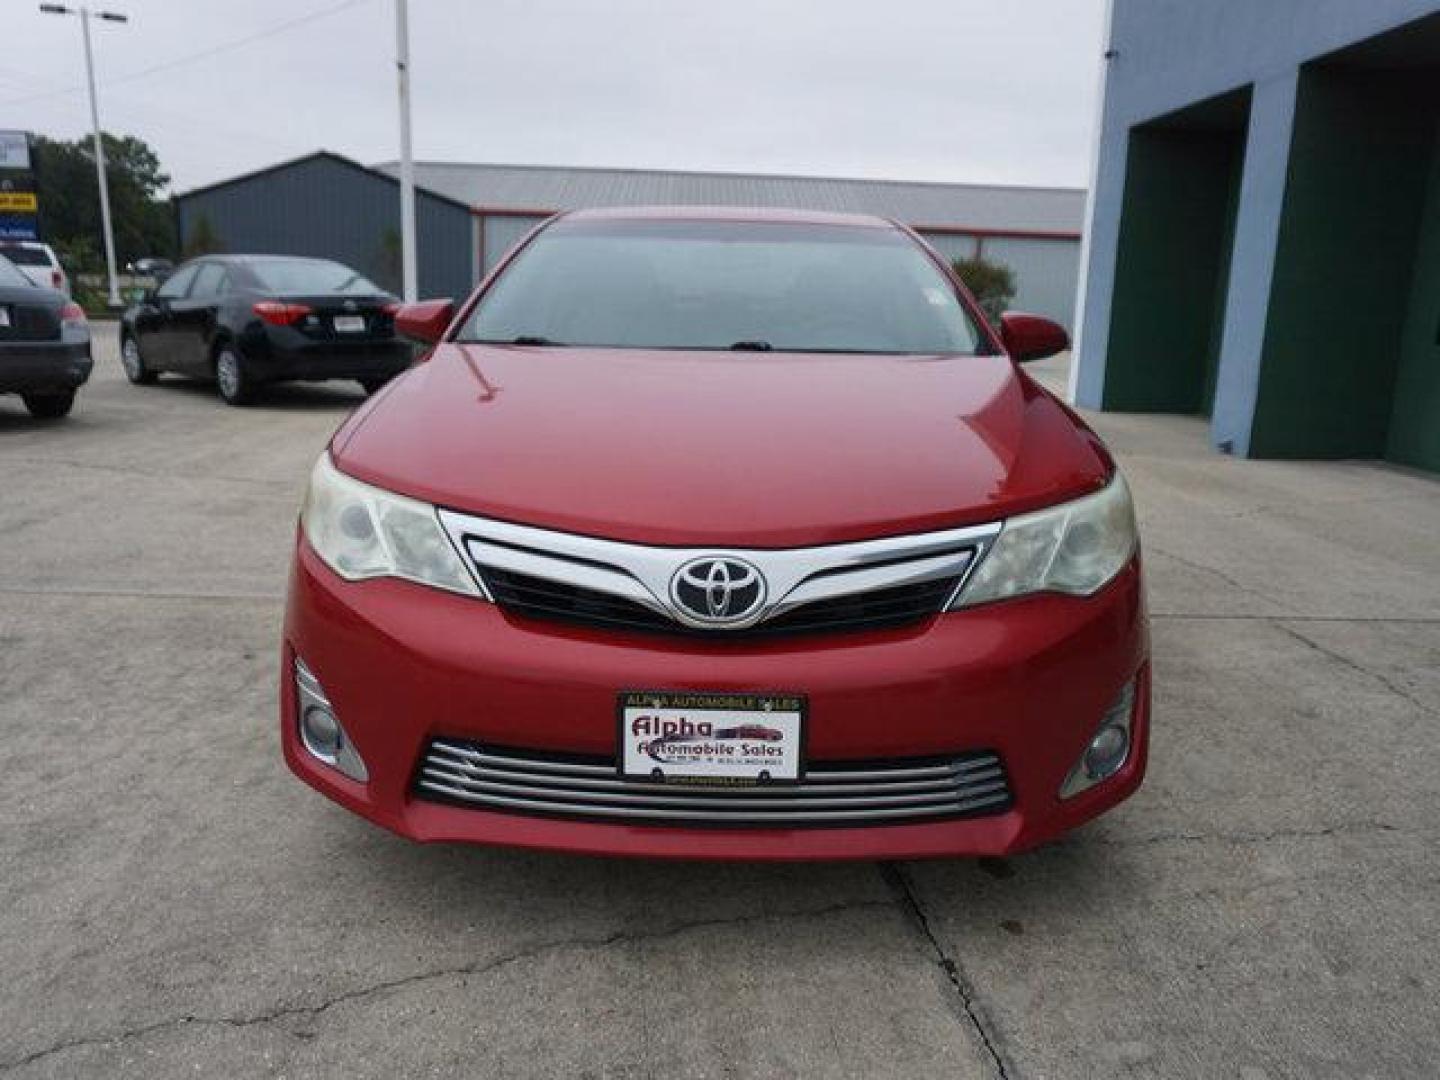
[176,151,1084,325]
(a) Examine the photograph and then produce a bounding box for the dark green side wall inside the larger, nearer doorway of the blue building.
[1250,68,1434,458]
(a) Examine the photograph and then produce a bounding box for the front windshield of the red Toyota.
[458,219,984,354]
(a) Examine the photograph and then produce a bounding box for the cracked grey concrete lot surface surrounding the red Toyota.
[0,336,1440,1080]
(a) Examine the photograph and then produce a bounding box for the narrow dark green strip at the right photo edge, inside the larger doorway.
[1385,125,1440,471]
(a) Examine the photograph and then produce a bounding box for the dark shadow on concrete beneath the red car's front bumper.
[317,821,1133,946]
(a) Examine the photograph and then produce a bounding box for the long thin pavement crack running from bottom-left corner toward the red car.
[0,900,894,1073]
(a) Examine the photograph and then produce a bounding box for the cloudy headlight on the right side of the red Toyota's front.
[953,472,1136,608]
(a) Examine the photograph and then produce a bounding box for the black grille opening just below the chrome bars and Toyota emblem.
[480,566,959,641]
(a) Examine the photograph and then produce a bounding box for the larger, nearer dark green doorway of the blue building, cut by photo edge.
[1250,16,1440,469]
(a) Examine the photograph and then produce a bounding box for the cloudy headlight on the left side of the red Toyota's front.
[300,452,482,596]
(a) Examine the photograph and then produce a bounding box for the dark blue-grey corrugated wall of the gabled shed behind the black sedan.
[176,157,477,297]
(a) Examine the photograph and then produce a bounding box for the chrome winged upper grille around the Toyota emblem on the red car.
[441,510,999,638]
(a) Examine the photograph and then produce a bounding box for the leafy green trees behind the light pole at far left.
[32,131,176,274]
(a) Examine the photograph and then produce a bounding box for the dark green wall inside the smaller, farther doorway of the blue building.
[1103,127,1244,413]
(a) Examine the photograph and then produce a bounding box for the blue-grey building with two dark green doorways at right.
[1073,0,1440,469]
